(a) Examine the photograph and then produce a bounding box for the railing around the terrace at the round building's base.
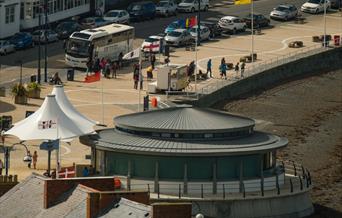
[121,161,312,199]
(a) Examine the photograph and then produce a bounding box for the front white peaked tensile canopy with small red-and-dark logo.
[5,95,94,141]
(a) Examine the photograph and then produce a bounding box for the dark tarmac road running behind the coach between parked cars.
[0,0,314,69]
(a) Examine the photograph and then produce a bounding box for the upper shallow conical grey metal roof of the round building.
[114,106,255,133]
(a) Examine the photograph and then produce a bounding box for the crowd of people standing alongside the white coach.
[87,52,123,78]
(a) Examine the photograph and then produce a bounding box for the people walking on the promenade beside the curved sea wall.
[207,57,246,79]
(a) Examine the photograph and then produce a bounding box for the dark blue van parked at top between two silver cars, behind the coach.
[127,1,156,21]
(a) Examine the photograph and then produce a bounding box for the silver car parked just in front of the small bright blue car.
[165,29,193,46]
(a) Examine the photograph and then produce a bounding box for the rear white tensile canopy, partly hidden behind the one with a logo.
[51,85,97,131]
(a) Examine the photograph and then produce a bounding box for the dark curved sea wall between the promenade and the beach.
[190,47,342,107]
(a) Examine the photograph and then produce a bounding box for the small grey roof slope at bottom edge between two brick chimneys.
[99,198,152,218]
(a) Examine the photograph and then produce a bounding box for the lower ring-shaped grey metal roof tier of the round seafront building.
[80,129,288,156]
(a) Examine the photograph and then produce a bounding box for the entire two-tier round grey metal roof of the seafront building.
[80,106,288,156]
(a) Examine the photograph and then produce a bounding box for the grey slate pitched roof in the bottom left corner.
[0,174,87,218]
